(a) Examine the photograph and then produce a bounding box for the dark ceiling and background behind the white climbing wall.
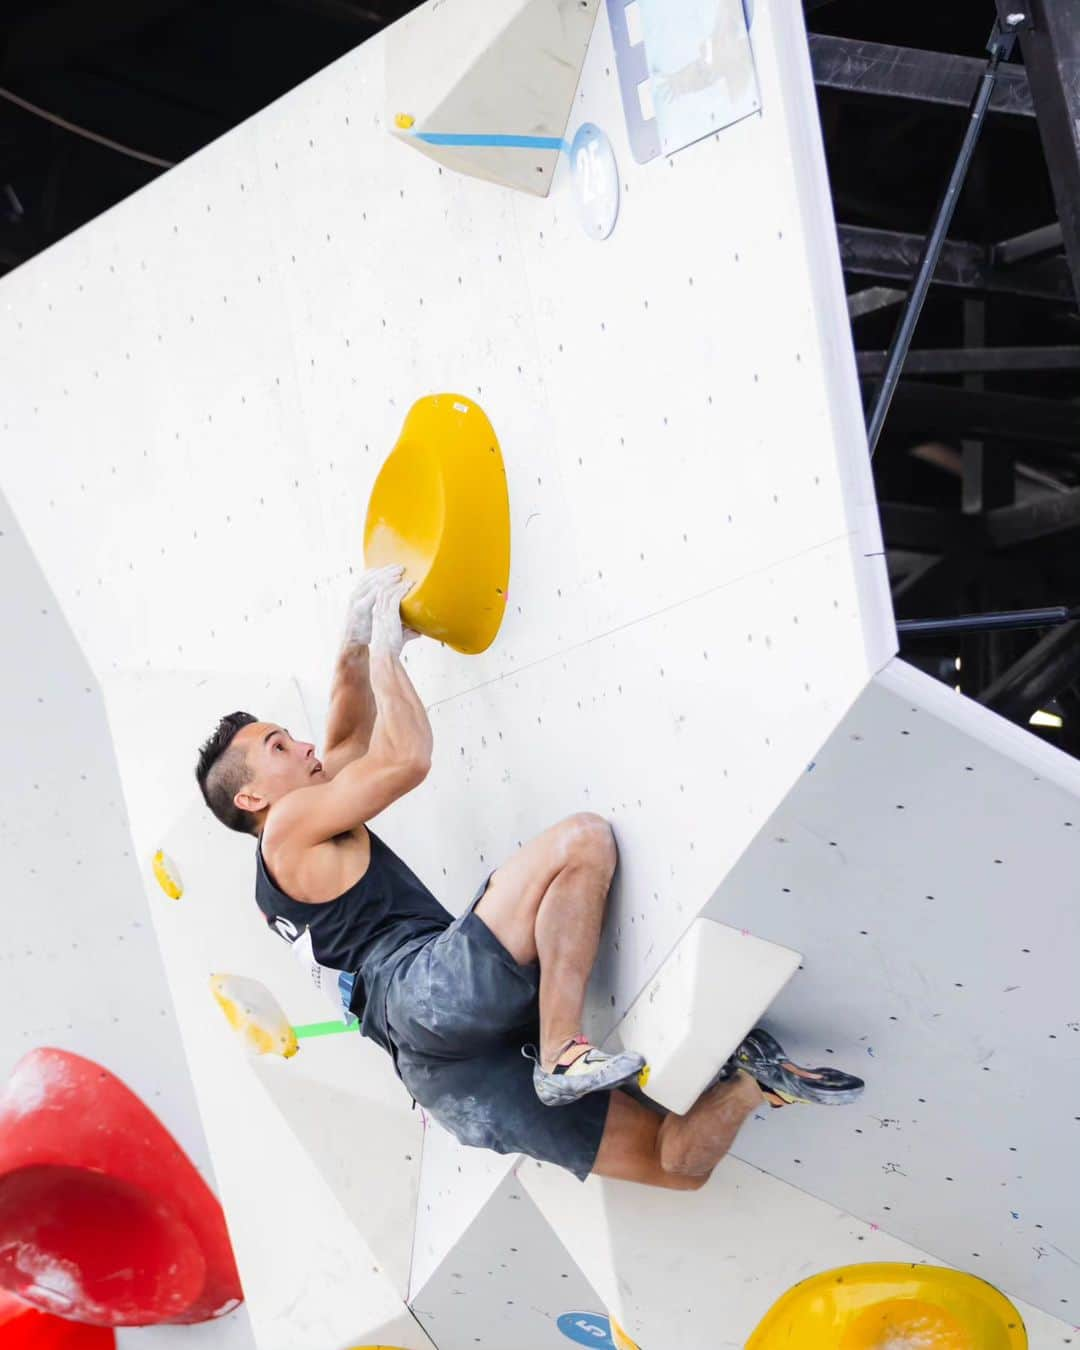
[0,0,1080,755]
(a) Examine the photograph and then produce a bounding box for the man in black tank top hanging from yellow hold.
[196,567,863,1191]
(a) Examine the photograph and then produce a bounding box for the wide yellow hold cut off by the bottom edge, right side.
[747,1261,1027,1350]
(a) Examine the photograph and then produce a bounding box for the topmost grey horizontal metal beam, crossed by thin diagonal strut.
[809,32,1035,117]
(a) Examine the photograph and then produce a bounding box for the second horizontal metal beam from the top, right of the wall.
[837,224,1080,305]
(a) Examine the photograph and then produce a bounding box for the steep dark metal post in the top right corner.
[1021,0,1080,300]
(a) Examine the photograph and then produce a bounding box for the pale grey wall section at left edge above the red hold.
[0,491,255,1350]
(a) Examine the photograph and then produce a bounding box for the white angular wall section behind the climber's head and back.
[109,672,429,1350]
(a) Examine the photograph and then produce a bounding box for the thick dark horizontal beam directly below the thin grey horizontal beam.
[869,381,1080,448]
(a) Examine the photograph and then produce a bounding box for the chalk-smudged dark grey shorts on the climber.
[386,878,610,1181]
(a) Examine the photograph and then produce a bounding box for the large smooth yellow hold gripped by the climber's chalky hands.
[363,394,510,653]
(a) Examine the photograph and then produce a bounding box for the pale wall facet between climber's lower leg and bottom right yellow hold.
[518,1144,1076,1350]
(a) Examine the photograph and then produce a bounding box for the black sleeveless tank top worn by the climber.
[255,830,454,1053]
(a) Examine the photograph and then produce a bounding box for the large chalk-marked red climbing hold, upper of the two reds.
[0,1049,243,1323]
